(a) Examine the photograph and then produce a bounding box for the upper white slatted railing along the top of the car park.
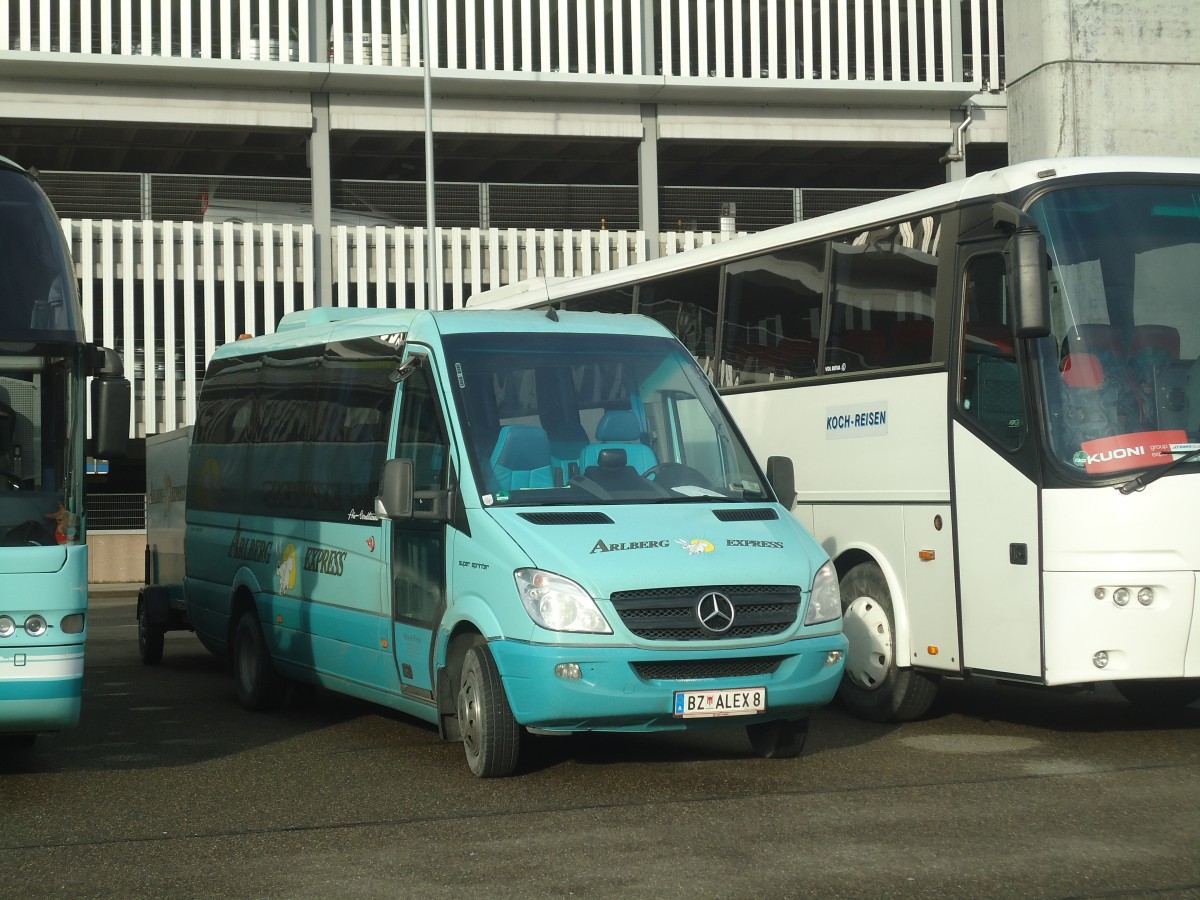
[0,0,1003,88]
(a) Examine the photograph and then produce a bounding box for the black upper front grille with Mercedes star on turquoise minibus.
[610,584,800,641]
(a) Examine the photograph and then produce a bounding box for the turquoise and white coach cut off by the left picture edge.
[0,157,130,746]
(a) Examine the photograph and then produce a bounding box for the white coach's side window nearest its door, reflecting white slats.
[824,216,940,373]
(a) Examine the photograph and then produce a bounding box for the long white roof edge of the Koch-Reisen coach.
[467,156,1200,310]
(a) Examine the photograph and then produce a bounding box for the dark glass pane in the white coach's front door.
[959,253,1027,450]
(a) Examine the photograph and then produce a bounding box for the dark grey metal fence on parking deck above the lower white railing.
[40,172,902,232]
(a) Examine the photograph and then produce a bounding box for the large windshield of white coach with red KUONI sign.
[1031,184,1200,478]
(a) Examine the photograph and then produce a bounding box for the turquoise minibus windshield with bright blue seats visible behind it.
[445,332,770,506]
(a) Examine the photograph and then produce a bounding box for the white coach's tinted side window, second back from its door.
[719,242,826,386]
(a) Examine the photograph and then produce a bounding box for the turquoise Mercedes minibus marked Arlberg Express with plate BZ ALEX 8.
[174,308,846,776]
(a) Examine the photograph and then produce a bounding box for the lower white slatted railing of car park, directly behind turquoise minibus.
[64,218,720,437]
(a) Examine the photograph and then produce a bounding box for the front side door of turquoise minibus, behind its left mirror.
[383,358,450,698]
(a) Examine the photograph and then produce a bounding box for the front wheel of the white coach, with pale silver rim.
[838,563,937,722]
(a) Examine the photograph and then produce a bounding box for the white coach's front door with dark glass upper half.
[952,250,1043,680]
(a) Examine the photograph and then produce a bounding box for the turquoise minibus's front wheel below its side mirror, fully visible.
[458,643,521,778]
